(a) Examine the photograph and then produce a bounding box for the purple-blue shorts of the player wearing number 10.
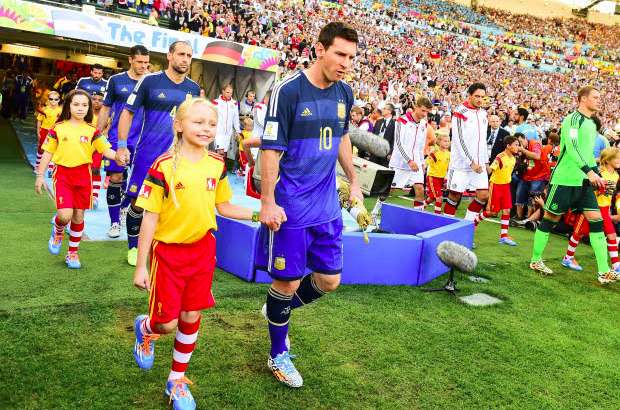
[257,218,343,280]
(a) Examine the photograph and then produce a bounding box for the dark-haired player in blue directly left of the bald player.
[97,45,149,238]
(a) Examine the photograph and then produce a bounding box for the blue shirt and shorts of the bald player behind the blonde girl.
[125,71,200,198]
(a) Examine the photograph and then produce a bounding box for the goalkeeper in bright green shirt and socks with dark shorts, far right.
[530,86,619,284]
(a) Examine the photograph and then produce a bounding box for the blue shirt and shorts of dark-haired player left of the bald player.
[103,71,144,173]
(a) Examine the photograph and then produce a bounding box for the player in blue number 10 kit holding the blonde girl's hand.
[259,23,363,387]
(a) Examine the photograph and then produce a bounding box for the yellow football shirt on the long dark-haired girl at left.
[42,121,112,168]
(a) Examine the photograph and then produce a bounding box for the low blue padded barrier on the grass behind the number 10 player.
[216,204,474,286]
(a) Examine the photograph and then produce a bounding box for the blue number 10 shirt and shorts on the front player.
[259,72,353,281]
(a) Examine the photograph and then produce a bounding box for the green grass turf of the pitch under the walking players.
[0,117,620,409]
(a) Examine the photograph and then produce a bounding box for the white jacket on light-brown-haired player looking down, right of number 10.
[390,113,428,170]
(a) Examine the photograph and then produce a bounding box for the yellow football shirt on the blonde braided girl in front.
[136,153,232,243]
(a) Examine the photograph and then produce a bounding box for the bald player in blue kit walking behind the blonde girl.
[117,41,200,266]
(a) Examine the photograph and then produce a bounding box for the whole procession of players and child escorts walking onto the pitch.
[35,23,620,409]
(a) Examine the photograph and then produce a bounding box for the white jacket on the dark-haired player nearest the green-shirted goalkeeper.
[449,102,489,170]
